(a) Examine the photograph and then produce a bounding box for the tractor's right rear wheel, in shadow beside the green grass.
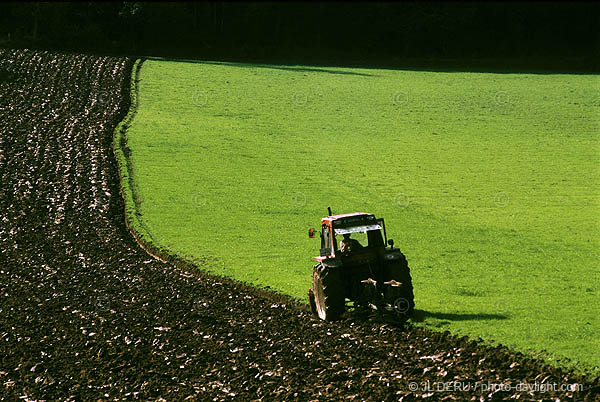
[383,253,415,317]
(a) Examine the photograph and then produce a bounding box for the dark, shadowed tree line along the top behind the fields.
[0,1,600,70]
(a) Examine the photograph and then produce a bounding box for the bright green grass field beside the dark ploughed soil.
[128,60,600,368]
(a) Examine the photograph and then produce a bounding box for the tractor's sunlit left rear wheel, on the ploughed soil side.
[312,265,346,321]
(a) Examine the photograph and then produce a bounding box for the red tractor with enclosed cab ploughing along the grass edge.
[308,208,415,321]
